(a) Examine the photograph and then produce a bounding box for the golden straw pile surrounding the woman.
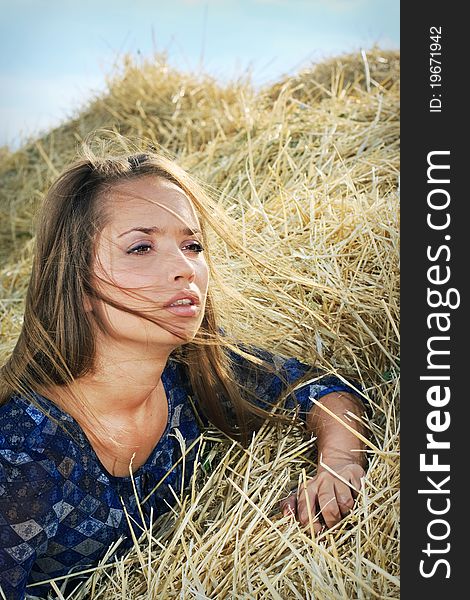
[0,48,399,600]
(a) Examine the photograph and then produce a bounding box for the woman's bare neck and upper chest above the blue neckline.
[41,343,178,476]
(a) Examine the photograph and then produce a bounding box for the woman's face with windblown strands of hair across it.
[90,176,209,350]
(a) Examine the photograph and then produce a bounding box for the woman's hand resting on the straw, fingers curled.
[281,463,365,533]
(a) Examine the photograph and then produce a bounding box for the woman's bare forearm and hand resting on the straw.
[281,392,366,532]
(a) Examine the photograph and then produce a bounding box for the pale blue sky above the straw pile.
[0,0,400,147]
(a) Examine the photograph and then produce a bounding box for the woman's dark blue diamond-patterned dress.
[0,354,360,600]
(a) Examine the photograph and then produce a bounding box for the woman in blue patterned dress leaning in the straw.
[0,149,364,598]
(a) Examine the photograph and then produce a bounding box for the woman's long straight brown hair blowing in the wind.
[0,151,300,441]
